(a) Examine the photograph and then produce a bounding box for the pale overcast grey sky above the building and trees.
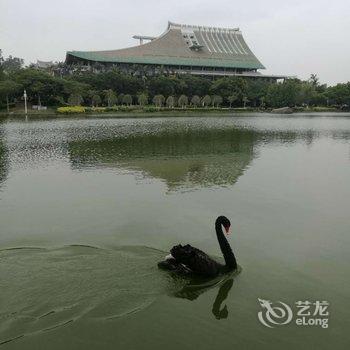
[0,0,350,85]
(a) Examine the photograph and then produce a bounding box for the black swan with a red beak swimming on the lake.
[158,216,237,277]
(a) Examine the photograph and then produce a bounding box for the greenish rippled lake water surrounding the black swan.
[0,114,350,350]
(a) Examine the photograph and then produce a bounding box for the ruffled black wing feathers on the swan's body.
[170,244,222,276]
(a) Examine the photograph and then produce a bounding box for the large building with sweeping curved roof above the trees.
[66,22,285,79]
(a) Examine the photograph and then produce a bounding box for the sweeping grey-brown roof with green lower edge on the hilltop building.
[66,22,265,69]
